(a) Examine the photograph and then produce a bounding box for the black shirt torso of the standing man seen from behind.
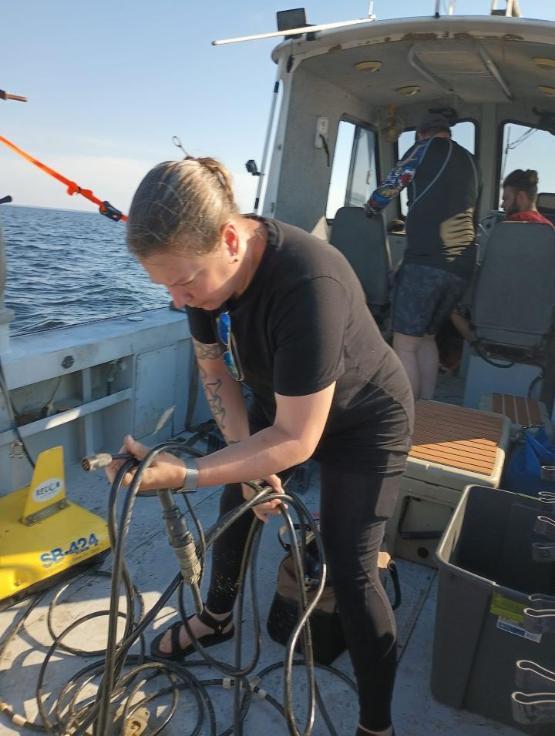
[404,138,479,278]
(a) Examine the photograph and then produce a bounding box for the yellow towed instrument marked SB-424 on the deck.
[0,447,110,608]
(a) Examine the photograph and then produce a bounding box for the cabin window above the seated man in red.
[500,123,555,208]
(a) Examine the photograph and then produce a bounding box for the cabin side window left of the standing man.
[326,120,378,219]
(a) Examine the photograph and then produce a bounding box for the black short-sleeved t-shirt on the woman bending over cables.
[187,219,413,468]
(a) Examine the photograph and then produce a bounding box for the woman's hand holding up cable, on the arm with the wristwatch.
[106,435,186,491]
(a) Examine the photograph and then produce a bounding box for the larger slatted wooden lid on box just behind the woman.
[410,401,503,476]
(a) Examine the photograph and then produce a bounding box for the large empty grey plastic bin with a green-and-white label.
[431,486,555,736]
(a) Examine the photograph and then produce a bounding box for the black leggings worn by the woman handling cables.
[206,463,403,731]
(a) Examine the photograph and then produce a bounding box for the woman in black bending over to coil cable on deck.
[116,158,413,736]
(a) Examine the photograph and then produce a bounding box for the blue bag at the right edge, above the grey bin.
[501,429,555,496]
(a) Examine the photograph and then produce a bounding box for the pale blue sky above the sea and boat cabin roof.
[0,0,555,216]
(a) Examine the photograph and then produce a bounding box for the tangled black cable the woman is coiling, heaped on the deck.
[0,442,356,736]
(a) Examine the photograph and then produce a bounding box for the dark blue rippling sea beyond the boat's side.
[0,204,170,335]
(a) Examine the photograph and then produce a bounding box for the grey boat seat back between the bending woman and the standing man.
[329,207,392,325]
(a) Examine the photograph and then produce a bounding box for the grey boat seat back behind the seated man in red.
[472,222,555,362]
